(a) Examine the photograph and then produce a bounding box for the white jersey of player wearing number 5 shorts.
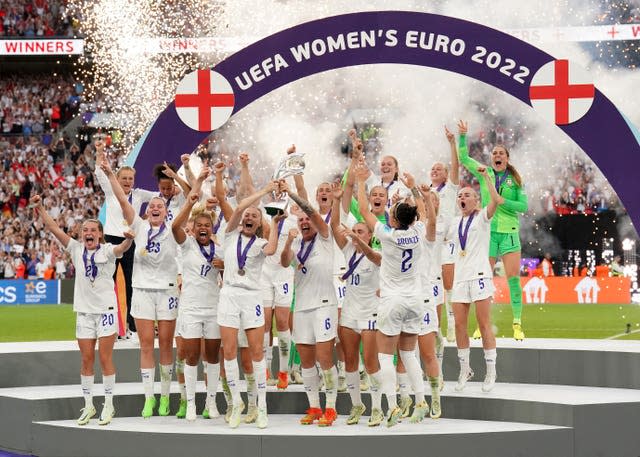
[448,207,493,282]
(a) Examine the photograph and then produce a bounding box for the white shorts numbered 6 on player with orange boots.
[291,306,338,344]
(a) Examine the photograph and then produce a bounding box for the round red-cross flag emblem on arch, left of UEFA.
[175,70,235,132]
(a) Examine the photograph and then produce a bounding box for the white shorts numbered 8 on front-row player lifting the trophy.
[218,286,264,329]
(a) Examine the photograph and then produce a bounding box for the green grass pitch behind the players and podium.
[0,304,640,342]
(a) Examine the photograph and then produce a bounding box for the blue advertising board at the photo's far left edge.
[0,279,60,305]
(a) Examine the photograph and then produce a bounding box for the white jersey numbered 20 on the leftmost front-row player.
[67,238,118,314]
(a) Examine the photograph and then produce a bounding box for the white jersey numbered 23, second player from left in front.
[131,216,178,289]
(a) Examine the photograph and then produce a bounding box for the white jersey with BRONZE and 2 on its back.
[374,221,425,297]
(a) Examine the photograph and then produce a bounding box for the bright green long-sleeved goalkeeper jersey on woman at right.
[458,135,529,233]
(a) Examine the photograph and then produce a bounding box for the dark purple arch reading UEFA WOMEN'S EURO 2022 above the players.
[128,11,640,227]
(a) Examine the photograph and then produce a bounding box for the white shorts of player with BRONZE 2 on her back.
[378,296,423,336]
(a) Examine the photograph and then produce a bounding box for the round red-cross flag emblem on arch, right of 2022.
[529,59,596,125]
